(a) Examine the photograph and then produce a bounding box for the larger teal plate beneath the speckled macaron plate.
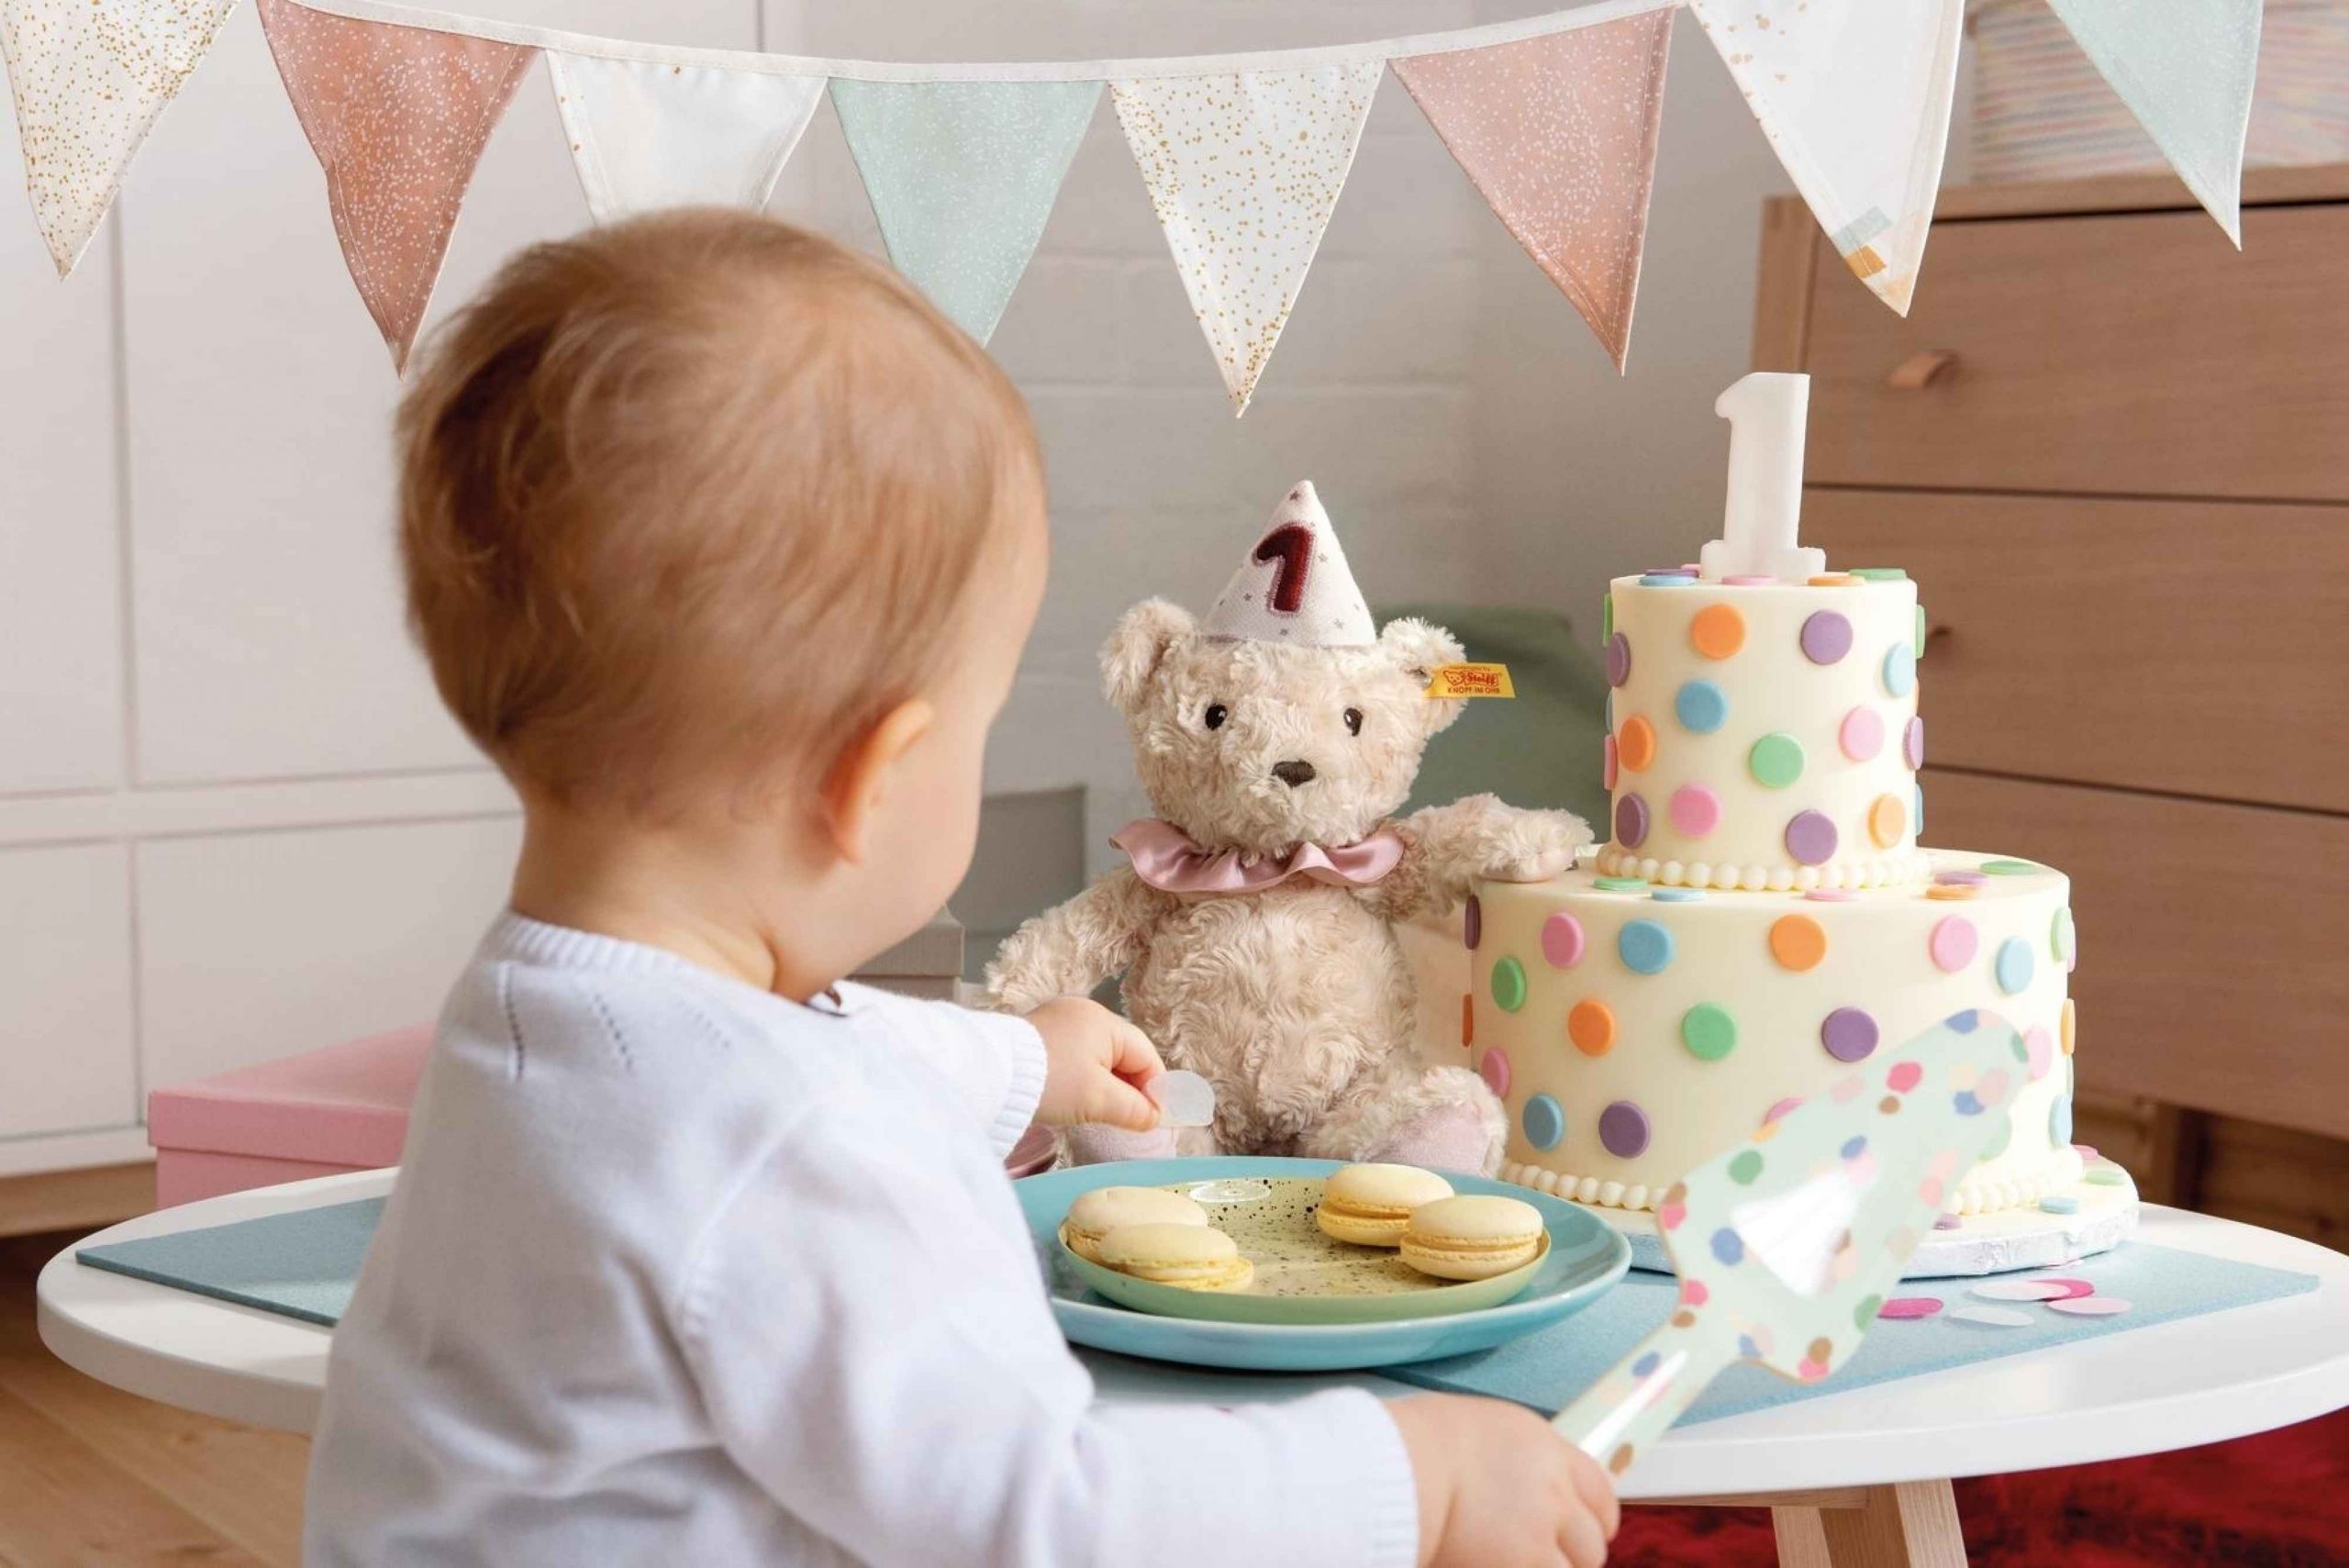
[1012,1155,1631,1371]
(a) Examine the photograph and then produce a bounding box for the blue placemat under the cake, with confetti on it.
[1384,1241,2316,1422]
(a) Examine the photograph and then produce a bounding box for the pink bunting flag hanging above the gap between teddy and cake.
[1393,0,1677,371]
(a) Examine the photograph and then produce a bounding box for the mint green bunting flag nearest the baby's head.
[831,80,1102,343]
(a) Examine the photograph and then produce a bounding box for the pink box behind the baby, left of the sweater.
[148,1023,432,1209]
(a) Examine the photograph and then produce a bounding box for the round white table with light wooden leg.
[40,1172,2349,1568]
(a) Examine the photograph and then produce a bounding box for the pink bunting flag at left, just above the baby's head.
[256,0,538,369]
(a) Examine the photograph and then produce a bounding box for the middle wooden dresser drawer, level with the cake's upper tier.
[1802,491,2349,812]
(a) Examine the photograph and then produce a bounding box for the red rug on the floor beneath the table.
[1609,1411,2349,1568]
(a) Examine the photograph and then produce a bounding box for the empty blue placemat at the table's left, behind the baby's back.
[72,1197,383,1329]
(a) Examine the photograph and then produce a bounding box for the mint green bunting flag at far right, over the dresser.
[2048,0,2260,249]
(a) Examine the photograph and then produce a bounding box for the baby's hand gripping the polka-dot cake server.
[1386,1395,1620,1568]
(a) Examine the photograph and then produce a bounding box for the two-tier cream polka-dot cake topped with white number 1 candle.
[1464,375,2081,1216]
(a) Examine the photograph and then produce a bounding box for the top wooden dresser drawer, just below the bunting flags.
[1802,205,2349,500]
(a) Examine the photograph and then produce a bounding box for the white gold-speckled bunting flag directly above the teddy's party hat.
[1108,61,1384,413]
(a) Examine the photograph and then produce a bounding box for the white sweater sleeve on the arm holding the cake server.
[679,1113,1419,1568]
